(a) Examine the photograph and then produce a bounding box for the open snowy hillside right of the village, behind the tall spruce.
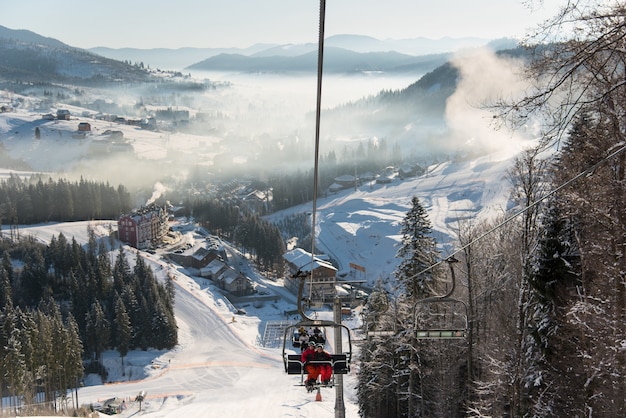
[269,144,522,286]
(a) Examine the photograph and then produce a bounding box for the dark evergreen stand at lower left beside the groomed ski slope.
[0,230,178,414]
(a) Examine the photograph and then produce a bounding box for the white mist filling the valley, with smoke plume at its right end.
[5,50,533,204]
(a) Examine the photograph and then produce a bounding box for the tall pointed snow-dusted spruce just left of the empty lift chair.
[359,197,438,416]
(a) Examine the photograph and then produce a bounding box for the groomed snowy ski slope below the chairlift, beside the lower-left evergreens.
[6,222,358,418]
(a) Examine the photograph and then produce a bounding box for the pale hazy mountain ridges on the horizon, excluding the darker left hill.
[90,35,516,72]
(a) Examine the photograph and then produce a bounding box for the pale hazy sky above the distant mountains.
[0,0,563,48]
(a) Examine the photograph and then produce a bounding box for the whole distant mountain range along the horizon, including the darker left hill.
[0,26,515,84]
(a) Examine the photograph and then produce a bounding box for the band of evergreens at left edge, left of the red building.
[0,174,132,226]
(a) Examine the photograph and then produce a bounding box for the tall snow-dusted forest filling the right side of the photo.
[357,1,626,418]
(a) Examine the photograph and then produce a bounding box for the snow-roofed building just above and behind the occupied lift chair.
[283,248,337,303]
